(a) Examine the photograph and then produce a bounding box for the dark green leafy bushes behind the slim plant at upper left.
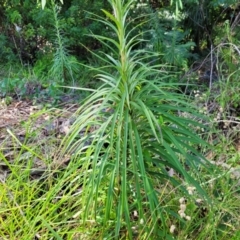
[0,0,110,64]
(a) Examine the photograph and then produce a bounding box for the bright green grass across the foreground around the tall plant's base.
[0,99,240,240]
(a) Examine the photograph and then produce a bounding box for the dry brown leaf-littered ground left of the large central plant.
[0,95,79,179]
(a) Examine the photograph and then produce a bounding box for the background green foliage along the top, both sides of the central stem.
[0,0,237,82]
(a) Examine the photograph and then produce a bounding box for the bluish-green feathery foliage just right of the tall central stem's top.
[122,1,196,70]
